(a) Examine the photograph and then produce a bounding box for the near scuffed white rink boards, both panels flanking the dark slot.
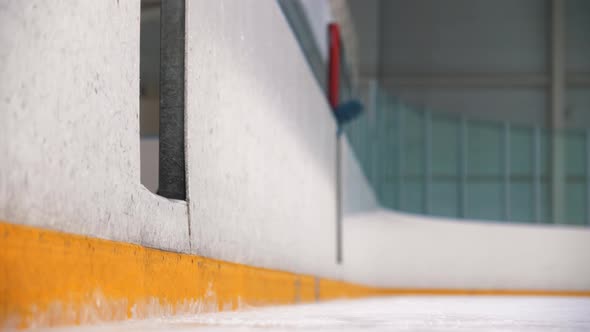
[0,1,366,280]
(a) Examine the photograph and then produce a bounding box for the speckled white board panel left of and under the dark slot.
[0,0,189,251]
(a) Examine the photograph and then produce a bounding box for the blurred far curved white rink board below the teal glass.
[343,209,590,291]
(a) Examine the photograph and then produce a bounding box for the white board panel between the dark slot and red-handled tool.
[186,0,336,274]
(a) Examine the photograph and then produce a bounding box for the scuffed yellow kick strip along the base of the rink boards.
[0,222,590,328]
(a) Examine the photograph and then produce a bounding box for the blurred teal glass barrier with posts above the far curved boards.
[345,89,590,225]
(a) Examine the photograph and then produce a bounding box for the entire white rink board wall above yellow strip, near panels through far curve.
[0,0,590,290]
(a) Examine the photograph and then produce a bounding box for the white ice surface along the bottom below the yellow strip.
[45,296,590,332]
